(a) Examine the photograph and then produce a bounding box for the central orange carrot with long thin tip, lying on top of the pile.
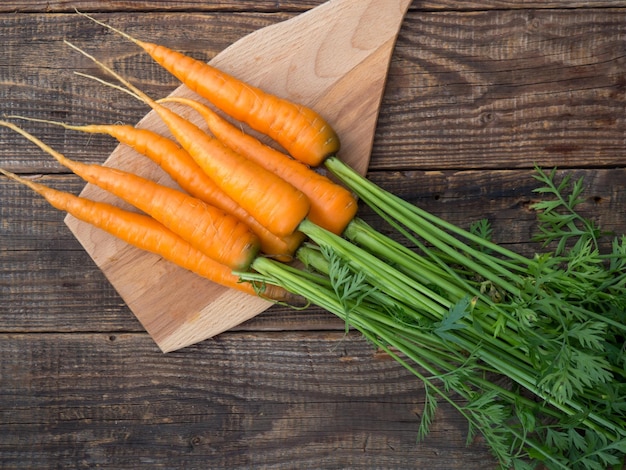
[65,41,310,237]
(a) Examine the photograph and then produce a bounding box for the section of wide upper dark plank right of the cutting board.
[371,9,626,170]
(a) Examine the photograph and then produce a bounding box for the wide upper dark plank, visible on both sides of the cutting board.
[0,9,626,171]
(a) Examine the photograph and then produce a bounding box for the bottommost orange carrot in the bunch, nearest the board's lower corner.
[0,168,288,300]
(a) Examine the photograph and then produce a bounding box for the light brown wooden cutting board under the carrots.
[66,0,410,352]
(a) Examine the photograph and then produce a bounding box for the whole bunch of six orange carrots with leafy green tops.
[0,15,626,468]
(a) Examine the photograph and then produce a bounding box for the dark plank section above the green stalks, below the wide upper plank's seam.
[364,168,626,254]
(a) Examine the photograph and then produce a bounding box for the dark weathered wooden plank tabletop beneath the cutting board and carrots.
[0,0,626,469]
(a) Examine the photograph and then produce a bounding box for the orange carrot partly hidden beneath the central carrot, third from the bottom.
[6,115,304,261]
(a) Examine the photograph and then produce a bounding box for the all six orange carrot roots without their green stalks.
[0,11,357,299]
